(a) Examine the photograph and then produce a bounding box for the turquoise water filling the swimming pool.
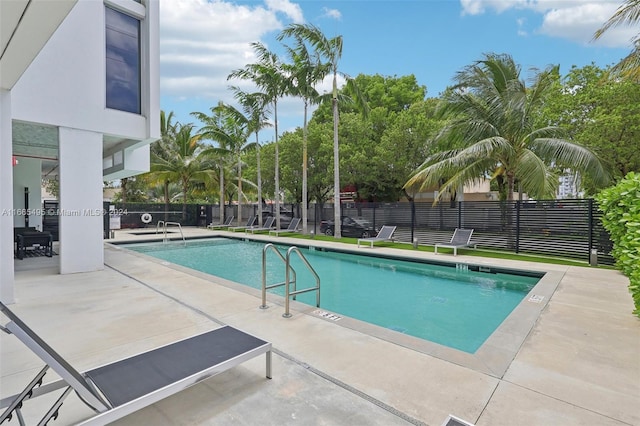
[126,238,540,353]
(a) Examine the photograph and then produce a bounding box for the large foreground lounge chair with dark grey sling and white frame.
[0,303,271,425]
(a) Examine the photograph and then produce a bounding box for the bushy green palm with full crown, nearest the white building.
[151,124,215,216]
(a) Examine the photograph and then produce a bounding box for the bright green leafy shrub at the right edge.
[597,172,640,317]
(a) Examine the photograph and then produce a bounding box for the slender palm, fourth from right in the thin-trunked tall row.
[230,86,271,227]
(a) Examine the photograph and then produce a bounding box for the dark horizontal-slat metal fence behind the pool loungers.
[105,199,614,265]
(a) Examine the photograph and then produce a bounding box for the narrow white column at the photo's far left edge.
[0,89,15,303]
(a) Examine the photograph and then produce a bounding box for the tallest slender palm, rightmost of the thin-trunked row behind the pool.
[282,24,366,238]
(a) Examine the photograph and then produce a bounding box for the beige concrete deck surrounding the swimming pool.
[0,229,640,426]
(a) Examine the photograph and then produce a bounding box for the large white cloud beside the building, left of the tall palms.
[160,0,304,102]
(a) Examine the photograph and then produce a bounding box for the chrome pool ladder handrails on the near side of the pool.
[260,244,320,318]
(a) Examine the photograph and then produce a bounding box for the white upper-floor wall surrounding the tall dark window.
[12,0,160,141]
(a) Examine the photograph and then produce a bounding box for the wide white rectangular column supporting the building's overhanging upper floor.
[59,127,104,274]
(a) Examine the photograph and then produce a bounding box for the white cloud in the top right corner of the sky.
[460,0,637,47]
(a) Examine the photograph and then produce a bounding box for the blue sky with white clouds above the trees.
[160,0,640,136]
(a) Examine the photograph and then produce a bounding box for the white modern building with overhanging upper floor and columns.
[0,0,160,303]
